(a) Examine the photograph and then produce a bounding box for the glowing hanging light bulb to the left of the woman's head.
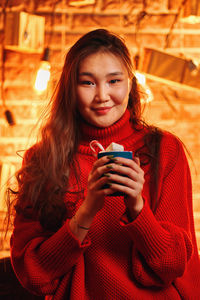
[34,61,51,93]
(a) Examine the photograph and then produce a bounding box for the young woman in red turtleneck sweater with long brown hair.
[11,29,200,300]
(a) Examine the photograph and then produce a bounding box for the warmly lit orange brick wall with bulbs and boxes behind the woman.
[0,0,200,260]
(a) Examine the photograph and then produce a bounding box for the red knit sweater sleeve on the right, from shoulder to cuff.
[121,134,195,287]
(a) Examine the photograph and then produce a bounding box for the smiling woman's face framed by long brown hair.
[77,52,131,128]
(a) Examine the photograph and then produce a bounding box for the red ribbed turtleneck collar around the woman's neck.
[77,109,134,154]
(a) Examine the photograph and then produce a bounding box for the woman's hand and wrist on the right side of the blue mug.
[107,157,144,218]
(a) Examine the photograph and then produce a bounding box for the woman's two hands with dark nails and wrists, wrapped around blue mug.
[70,156,144,242]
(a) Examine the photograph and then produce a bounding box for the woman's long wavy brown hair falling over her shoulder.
[7,29,161,230]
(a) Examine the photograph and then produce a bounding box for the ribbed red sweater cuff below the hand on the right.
[120,201,172,256]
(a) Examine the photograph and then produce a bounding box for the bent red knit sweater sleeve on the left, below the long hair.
[11,216,90,295]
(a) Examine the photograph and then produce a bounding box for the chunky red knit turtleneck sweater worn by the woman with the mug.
[11,111,200,300]
